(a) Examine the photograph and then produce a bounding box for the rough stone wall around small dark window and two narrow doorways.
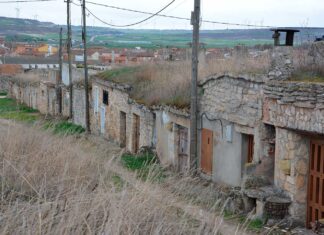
[91,79,155,152]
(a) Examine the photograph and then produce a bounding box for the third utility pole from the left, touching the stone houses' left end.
[82,0,90,133]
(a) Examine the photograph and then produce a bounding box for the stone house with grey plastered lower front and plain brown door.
[198,74,274,186]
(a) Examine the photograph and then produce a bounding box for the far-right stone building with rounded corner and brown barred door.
[263,81,324,225]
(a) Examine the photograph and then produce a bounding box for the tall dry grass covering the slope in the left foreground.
[0,124,225,234]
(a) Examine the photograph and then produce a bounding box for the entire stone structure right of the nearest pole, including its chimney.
[198,42,324,227]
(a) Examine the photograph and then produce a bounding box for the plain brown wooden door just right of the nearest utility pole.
[200,129,213,174]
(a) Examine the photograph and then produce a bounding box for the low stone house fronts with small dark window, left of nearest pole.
[91,77,190,172]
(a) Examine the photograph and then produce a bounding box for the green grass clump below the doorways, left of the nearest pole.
[121,151,166,182]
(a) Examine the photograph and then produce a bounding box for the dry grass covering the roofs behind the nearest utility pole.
[99,54,270,109]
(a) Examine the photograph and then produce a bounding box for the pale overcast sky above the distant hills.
[0,0,324,29]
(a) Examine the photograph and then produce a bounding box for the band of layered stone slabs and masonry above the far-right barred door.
[263,81,324,134]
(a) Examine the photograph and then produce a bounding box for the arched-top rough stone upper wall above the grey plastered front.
[199,75,263,127]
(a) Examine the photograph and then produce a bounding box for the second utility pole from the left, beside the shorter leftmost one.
[66,0,73,119]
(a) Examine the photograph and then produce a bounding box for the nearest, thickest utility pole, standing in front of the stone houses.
[190,0,200,171]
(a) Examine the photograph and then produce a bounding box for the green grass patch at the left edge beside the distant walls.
[0,98,39,122]
